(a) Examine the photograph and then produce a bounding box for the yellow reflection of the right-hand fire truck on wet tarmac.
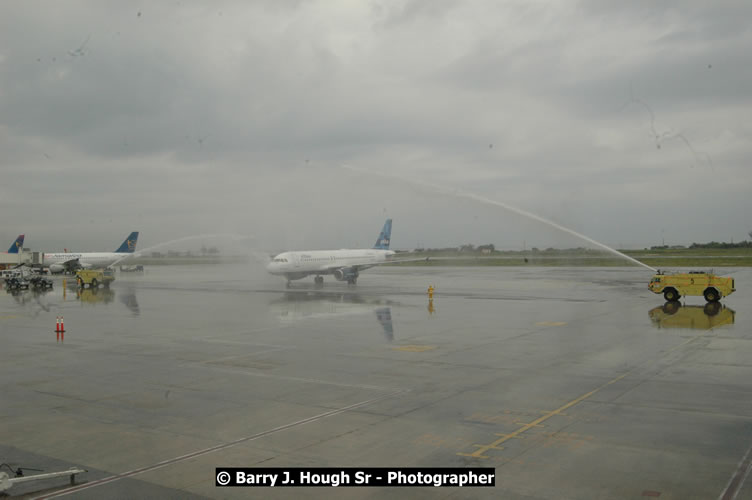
[648,302,736,330]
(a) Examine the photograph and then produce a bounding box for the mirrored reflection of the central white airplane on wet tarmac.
[269,291,394,341]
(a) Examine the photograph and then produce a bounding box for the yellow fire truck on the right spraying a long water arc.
[648,271,736,302]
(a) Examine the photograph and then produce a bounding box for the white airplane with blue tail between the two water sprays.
[266,219,418,287]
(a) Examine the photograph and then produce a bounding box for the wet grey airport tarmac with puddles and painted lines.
[0,265,752,499]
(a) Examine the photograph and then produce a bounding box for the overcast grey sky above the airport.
[0,0,752,251]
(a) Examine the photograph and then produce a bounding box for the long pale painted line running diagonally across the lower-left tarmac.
[35,390,404,500]
